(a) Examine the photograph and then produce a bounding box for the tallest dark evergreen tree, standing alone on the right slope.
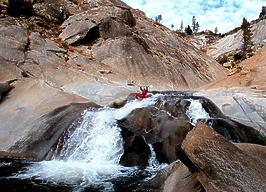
[241,17,253,58]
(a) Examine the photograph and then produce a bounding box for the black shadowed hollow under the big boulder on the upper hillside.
[72,26,100,46]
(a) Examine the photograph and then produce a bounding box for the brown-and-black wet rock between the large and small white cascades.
[119,95,192,163]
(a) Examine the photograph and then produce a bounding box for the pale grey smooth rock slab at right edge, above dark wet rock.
[200,88,266,134]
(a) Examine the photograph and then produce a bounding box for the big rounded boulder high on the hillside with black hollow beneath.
[59,6,135,44]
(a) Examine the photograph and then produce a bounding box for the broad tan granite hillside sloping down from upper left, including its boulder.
[0,0,225,92]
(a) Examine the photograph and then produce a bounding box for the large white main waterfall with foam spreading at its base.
[17,96,161,189]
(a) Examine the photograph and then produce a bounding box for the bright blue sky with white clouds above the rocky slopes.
[123,0,266,33]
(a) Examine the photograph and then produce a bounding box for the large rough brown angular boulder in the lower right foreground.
[182,124,266,192]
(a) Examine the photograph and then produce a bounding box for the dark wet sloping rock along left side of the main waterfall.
[9,103,99,160]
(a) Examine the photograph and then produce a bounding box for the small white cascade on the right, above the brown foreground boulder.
[186,99,210,126]
